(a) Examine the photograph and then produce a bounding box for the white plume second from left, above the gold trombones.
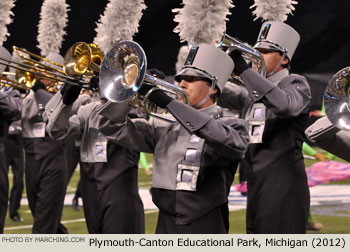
[37,0,69,56]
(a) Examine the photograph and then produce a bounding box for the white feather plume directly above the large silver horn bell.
[94,0,146,51]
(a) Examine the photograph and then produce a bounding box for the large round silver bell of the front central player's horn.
[99,41,147,103]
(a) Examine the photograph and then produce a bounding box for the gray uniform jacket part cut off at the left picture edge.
[0,90,22,151]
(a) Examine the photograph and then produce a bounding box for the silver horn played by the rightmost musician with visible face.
[217,34,266,78]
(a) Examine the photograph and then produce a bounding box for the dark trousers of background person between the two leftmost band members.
[5,135,24,216]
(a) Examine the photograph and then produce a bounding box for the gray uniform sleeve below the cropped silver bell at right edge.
[305,117,350,162]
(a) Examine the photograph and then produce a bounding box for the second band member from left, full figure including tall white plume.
[22,0,68,234]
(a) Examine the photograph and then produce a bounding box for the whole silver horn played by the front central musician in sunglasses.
[99,41,188,122]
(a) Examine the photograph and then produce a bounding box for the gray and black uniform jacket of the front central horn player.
[99,101,248,225]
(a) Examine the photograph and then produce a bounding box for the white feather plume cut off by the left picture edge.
[0,0,15,46]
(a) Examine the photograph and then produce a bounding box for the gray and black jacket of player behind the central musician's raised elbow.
[45,93,139,190]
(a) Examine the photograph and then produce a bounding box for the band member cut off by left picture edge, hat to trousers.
[0,46,22,234]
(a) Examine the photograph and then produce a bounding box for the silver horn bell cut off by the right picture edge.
[323,66,350,130]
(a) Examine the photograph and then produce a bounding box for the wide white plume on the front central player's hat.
[173,0,234,45]
